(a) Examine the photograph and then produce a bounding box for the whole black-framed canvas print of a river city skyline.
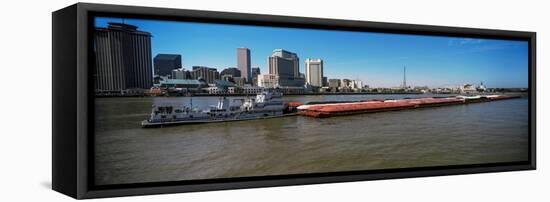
[52,3,536,199]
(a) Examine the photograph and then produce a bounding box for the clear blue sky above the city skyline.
[96,18,528,87]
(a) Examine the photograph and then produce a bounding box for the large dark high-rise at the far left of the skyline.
[93,23,153,91]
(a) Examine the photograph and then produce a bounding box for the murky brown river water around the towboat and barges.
[94,95,528,185]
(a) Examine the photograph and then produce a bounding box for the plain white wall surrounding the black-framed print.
[0,0,550,201]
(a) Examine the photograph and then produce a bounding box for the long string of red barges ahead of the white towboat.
[297,95,520,118]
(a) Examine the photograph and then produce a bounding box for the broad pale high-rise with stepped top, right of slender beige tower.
[268,49,304,86]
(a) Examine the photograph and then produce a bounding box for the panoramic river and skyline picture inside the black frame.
[93,17,529,185]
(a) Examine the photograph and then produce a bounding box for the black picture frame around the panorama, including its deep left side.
[52,3,536,199]
